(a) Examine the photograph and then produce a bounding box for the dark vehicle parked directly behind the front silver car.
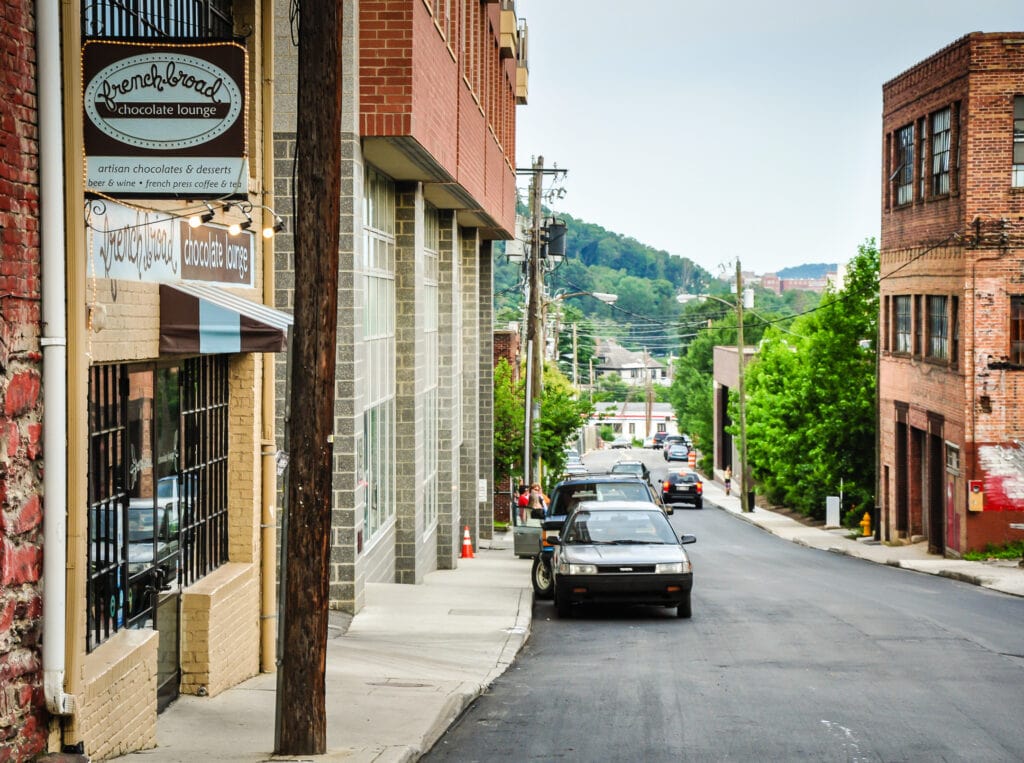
[528,474,668,599]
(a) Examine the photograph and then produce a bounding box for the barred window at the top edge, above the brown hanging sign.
[82,0,233,41]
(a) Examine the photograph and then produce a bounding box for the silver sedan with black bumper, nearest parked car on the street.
[550,501,696,618]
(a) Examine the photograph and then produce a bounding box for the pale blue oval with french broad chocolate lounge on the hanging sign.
[85,52,243,151]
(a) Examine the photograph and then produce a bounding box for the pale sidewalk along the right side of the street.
[705,480,1024,596]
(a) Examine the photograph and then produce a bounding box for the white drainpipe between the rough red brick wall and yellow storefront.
[36,0,74,715]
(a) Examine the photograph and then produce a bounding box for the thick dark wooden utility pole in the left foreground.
[276,0,342,755]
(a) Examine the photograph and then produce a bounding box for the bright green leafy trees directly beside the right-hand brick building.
[746,240,879,518]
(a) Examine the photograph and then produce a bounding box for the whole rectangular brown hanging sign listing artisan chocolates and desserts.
[82,41,249,199]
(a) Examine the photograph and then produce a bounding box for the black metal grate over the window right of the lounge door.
[181,355,228,586]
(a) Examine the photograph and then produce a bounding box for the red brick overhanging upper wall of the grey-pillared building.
[359,0,515,232]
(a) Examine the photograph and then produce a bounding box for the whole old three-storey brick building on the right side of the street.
[879,33,1024,556]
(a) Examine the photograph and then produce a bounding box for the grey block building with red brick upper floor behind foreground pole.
[273,0,526,612]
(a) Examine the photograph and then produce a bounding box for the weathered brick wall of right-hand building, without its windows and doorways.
[880,33,1024,551]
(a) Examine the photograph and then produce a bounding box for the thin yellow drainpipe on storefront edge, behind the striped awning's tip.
[259,0,280,673]
